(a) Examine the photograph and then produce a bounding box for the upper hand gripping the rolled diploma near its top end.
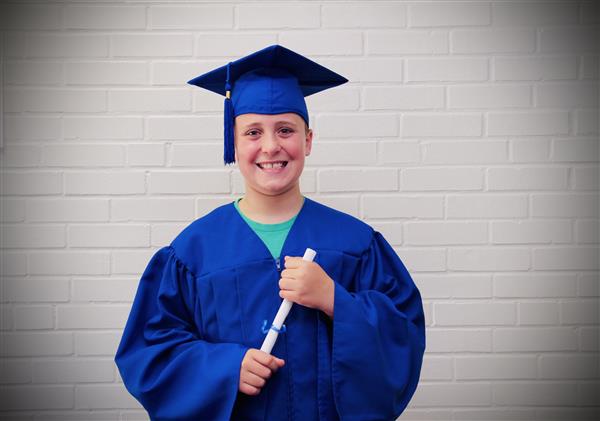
[279,256,335,318]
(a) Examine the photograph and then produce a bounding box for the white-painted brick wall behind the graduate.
[0,0,600,421]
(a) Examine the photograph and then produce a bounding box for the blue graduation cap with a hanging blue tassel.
[188,45,348,164]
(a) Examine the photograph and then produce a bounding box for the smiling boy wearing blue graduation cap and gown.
[115,45,425,421]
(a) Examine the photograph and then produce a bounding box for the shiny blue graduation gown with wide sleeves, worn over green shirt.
[115,198,425,421]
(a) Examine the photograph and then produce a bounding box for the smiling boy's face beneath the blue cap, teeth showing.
[235,113,313,196]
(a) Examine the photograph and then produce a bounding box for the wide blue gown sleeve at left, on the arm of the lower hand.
[115,246,247,420]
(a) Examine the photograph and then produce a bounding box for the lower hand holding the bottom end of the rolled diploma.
[239,348,285,396]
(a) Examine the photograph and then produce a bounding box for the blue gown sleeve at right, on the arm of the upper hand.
[332,232,425,421]
